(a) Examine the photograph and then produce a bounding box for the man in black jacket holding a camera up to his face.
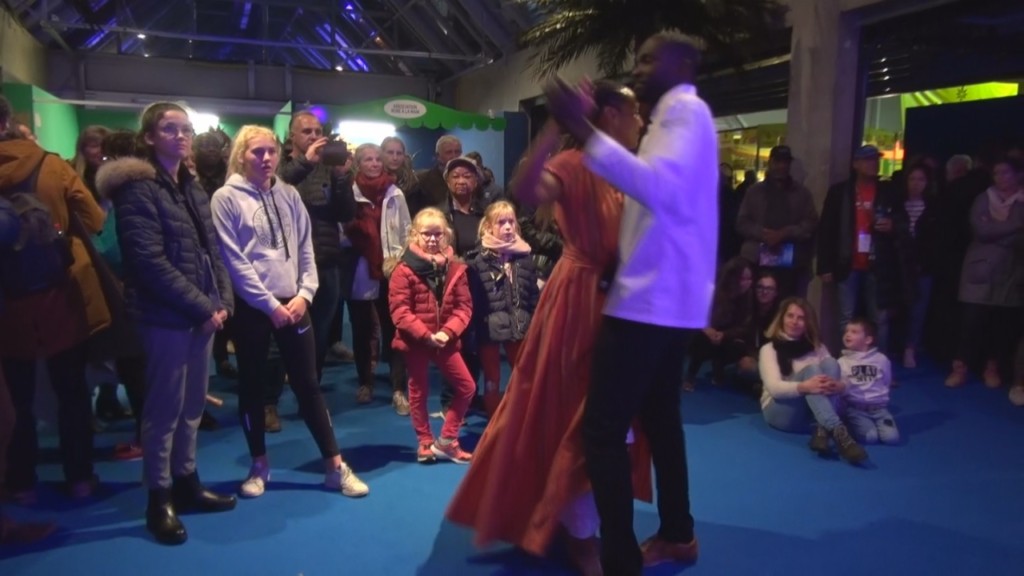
[278,112,356,389]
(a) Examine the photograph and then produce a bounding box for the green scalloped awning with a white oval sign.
[332,95,506,130]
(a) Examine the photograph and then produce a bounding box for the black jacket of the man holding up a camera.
[278,156,355,266]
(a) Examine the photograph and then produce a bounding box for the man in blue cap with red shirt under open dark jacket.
[818,146,909,353]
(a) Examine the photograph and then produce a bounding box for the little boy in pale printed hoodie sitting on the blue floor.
[839,318,899,444]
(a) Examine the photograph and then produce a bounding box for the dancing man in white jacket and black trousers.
[547,33,719,575]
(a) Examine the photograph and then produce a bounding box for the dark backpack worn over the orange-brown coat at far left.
[0,154,75,298]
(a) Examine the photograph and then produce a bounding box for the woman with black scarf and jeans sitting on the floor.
[758,298,867,462]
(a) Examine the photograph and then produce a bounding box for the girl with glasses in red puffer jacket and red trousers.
[388,208,476,464]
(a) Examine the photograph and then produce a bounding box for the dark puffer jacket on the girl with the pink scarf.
[466,249,541,342]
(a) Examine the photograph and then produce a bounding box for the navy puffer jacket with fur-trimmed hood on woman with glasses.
[104,158,234,329]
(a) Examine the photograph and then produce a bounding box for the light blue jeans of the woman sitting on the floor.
[763,358,843,433]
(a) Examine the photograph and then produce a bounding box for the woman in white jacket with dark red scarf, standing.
[344,143,412,416]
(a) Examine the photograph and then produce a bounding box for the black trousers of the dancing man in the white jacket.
[583,316,693,576]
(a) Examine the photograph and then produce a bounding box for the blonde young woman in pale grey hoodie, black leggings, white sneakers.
[213,126,370,498]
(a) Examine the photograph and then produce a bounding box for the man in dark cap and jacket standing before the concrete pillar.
[735,146,818,298]
